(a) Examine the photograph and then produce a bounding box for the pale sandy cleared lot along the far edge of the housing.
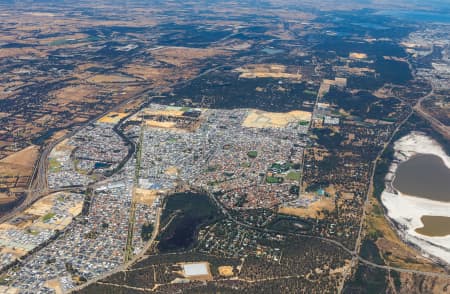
[242,110,311,128]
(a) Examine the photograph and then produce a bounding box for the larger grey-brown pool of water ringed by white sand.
[392,154,450,202]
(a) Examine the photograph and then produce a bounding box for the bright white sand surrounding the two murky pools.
[381,132,450,264]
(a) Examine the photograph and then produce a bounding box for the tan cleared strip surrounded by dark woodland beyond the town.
[235,64,302,80]
